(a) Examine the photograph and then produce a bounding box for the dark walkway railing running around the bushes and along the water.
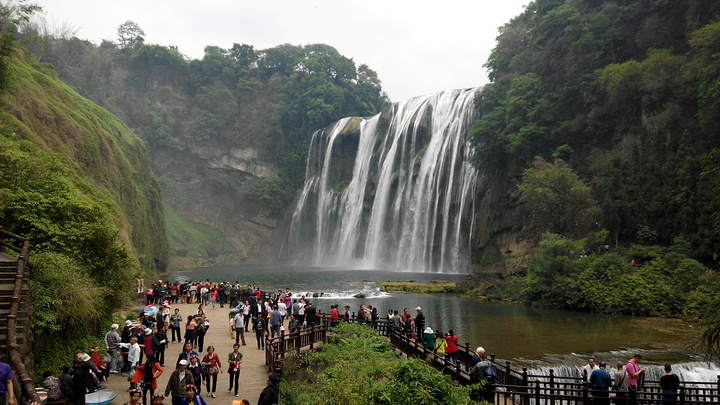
[265,314,720,405]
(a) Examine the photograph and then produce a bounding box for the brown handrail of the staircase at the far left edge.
[0,226,40,403]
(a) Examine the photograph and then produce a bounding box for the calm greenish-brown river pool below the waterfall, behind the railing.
[166,265,720,381]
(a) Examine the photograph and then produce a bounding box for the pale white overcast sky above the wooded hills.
[30,0,530,101]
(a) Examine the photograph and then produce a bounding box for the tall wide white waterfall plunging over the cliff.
[283,89,479,273]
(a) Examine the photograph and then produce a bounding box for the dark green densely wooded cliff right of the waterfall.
[472,0,720,353]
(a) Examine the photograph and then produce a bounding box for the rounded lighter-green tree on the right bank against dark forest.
[518,157,595,235]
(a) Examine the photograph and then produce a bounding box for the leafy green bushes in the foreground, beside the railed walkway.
[280,322,475,405]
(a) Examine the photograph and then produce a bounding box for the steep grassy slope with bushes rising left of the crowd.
[0,39,168,370]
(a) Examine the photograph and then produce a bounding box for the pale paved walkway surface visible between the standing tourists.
[105,304,268,405]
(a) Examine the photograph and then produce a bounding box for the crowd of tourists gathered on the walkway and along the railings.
[35,280,679,405]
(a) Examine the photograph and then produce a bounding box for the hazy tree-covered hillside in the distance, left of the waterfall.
[24,34,384,269]
